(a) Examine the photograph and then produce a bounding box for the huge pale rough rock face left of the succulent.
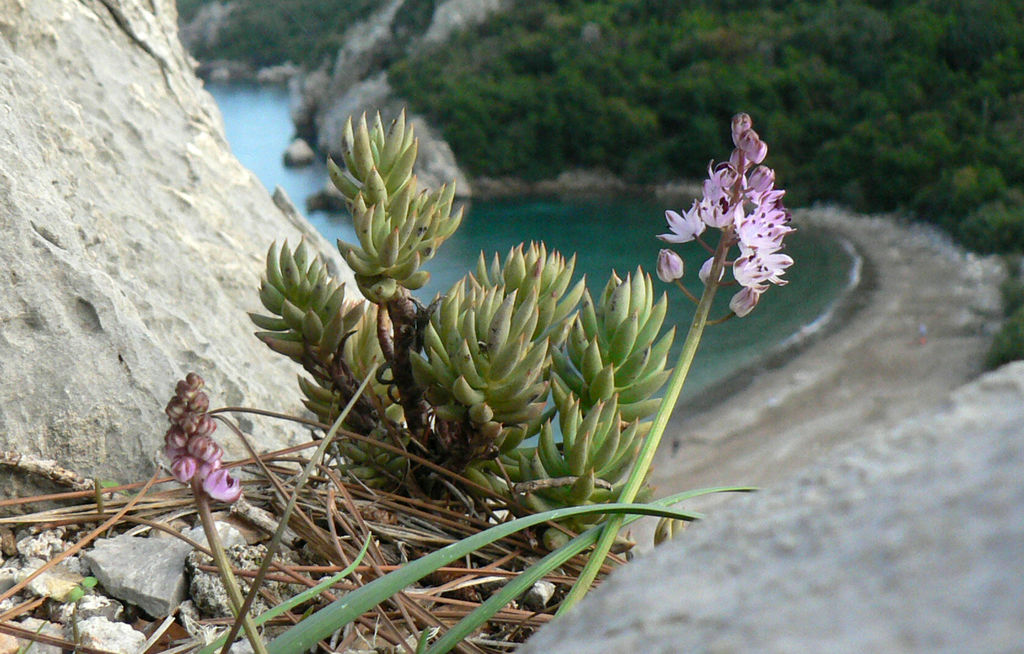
[0,0,356,480]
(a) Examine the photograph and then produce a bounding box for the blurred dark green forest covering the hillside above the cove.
[182,0,1024,252]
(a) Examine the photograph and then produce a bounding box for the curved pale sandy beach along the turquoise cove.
[638,208,1004,521]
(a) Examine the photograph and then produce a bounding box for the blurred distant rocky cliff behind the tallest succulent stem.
[291,0,509,197]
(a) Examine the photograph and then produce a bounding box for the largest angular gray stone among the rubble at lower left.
[83,535,191,618]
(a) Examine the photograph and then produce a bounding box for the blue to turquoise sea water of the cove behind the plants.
[209,85,852,397]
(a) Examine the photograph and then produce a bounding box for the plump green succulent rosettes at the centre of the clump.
[412,245,584,469]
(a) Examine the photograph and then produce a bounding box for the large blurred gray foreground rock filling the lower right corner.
[519,362,1024,654]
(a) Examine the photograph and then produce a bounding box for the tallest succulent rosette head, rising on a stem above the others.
[328,112,462,304]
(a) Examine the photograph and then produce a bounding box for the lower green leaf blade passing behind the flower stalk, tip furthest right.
[427,486,754,654]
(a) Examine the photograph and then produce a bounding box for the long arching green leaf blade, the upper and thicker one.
[267,504,693,654]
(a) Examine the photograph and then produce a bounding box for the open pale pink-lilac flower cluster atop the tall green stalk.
[658,114,794,317]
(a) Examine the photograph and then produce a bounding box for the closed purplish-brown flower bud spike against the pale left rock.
[164,373,242,503]
